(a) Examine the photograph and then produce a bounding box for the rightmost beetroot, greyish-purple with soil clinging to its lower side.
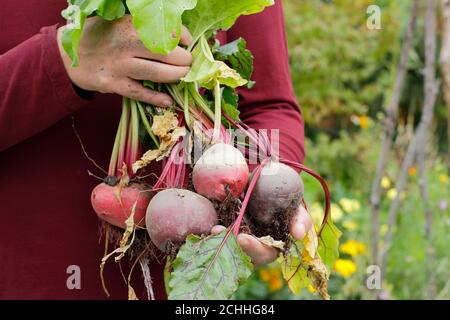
[247,161,304,224]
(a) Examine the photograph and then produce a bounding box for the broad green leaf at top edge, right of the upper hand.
[183,0,274,43]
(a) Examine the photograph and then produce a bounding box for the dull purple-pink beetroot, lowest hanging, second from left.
[146,189,218,251]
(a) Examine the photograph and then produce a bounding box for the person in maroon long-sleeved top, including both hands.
[0,0,307,299]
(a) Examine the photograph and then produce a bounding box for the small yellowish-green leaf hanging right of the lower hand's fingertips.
[318,219,342,268]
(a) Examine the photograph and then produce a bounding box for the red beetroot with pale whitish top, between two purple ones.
[192,143,249,201]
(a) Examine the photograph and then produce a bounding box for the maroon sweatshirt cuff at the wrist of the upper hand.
[40,24,94,112]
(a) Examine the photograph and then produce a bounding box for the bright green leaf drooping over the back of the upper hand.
[126,0,197,55]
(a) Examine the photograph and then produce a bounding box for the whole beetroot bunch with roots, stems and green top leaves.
[62,0,329,297]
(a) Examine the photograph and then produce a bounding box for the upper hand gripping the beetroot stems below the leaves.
[58,15,192,107]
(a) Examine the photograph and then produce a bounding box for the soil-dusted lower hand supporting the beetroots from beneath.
[211,206,313,266]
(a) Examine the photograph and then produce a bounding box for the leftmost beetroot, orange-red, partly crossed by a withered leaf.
[91,183,152,228]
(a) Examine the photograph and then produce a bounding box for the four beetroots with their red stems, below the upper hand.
[91,87,328,253]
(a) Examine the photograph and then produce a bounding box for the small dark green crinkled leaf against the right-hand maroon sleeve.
[214,38,253,81]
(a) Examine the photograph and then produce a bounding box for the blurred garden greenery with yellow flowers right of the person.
[237,0,450,299]
